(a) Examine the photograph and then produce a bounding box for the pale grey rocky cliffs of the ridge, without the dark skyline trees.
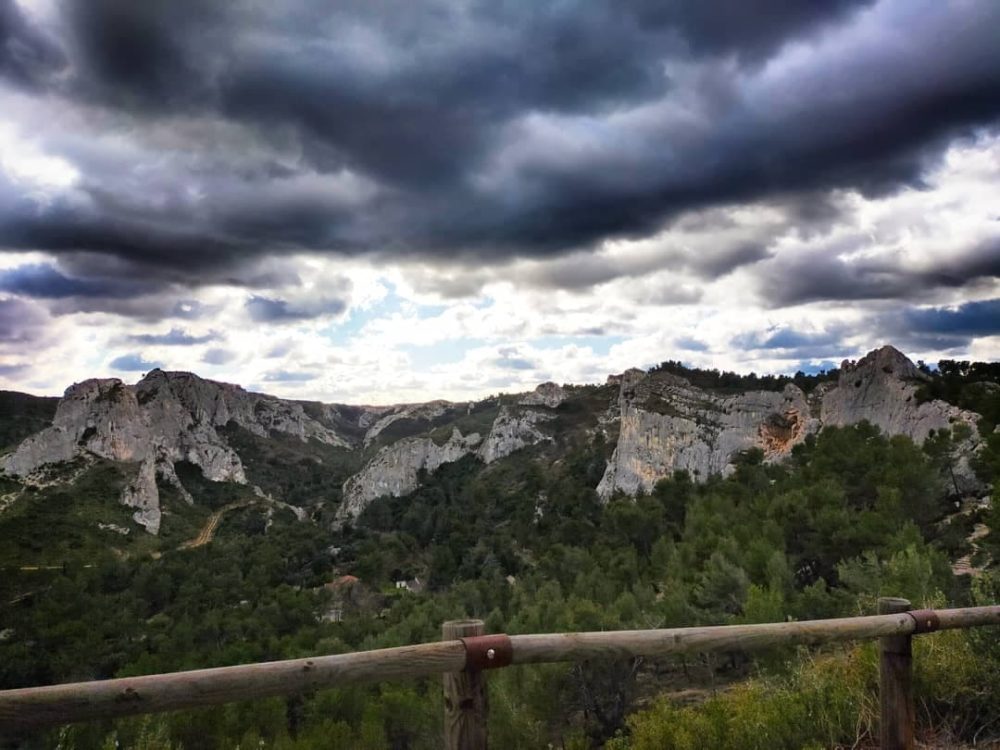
[0,346,978,533]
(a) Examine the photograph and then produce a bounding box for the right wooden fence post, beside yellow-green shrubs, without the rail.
[878,597,913,750]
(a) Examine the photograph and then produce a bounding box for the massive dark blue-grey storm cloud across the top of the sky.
[0,0,1000,294]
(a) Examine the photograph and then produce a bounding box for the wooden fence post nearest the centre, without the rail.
[441,620,488,750]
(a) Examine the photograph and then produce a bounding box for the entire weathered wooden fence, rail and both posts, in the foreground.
[0,599,1000,750]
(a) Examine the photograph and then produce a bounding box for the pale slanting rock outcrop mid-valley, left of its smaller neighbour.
[337,429,483,520]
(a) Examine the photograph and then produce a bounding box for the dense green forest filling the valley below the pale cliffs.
[0,362,1000,750]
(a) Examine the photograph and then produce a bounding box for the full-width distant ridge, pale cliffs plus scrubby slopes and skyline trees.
[0,346,1000,534]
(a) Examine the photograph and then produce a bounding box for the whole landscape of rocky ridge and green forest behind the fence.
[0,347,1000,750]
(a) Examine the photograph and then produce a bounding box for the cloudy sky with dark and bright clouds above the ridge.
[0,0,1000,403]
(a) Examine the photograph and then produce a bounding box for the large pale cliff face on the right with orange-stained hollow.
[597,346,977,498]
